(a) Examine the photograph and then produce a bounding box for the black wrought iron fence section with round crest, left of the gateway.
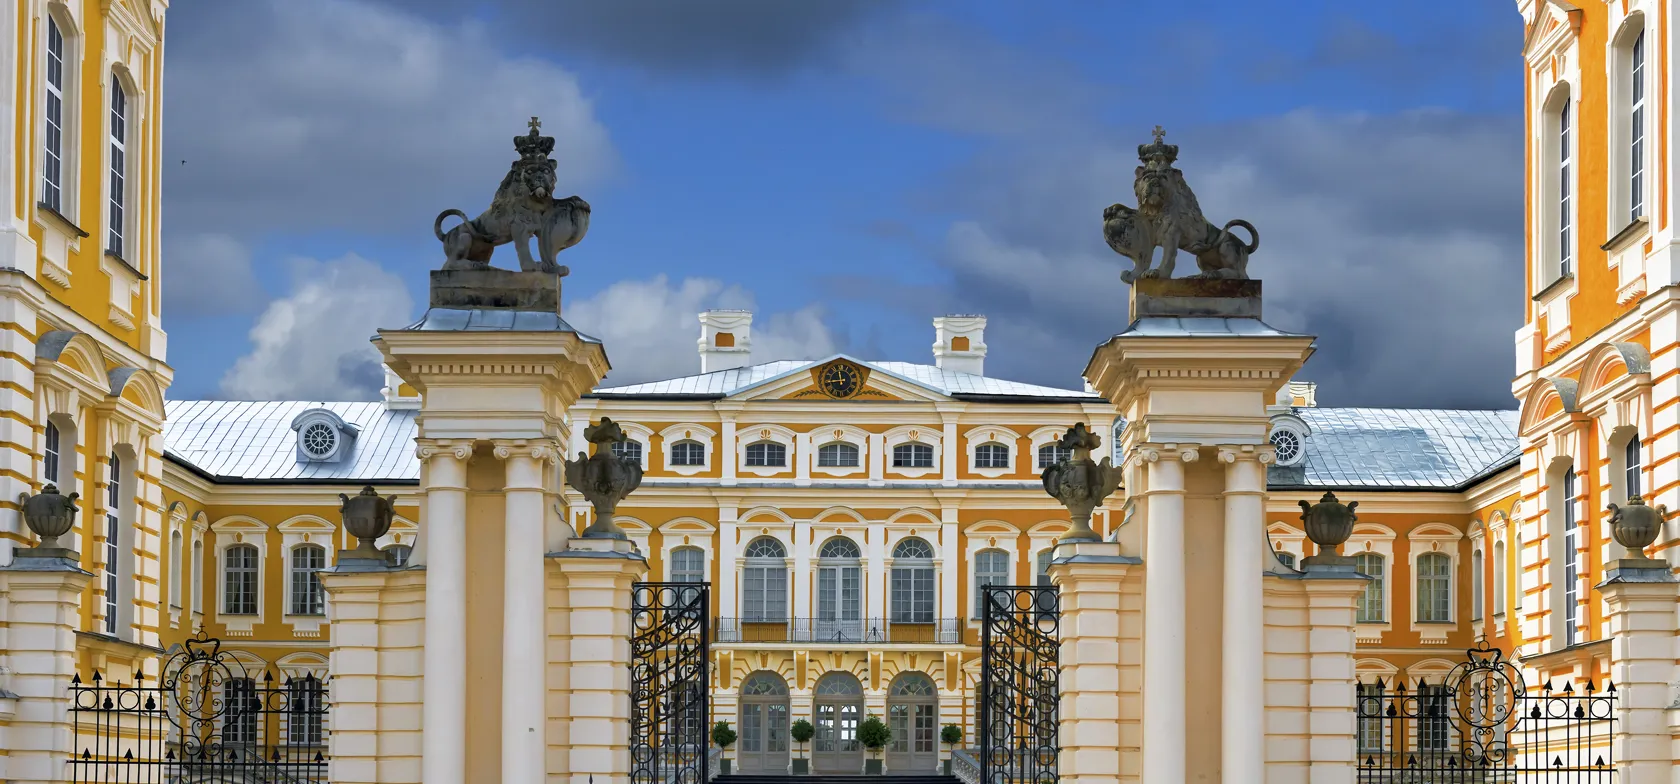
[69,631,328,784]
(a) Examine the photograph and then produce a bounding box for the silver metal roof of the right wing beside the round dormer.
[1267,408,1522,490]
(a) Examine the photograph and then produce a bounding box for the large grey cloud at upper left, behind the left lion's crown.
[165,0,615,237]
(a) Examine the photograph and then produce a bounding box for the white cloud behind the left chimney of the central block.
[561,275,837,386]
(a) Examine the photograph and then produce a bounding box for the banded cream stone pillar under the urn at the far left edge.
[0,549,92,784]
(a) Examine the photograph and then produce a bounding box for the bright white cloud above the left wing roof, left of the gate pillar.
[222,253,413,400]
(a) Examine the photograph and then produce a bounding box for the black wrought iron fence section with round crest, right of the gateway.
[1356,641,1616,784]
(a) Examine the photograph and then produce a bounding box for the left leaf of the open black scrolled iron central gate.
[630,583,711,784]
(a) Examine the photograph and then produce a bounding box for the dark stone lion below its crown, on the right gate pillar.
[1102,166,1260,284]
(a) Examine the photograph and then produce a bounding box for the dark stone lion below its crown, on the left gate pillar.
[432,159,590,275]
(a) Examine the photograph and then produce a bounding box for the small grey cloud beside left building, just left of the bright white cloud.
[163,232,265,317]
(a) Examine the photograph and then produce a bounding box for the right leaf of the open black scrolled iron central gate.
[979,586,1062,784]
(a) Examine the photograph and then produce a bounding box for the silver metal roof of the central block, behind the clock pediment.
[593,354,1102,401]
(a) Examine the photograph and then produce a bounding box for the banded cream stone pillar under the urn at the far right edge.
[1598,559,1680,784]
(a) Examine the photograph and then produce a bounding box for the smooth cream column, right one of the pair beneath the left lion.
[493,440,554,784]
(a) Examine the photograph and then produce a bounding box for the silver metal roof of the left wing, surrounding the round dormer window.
[163,400,420,482]
